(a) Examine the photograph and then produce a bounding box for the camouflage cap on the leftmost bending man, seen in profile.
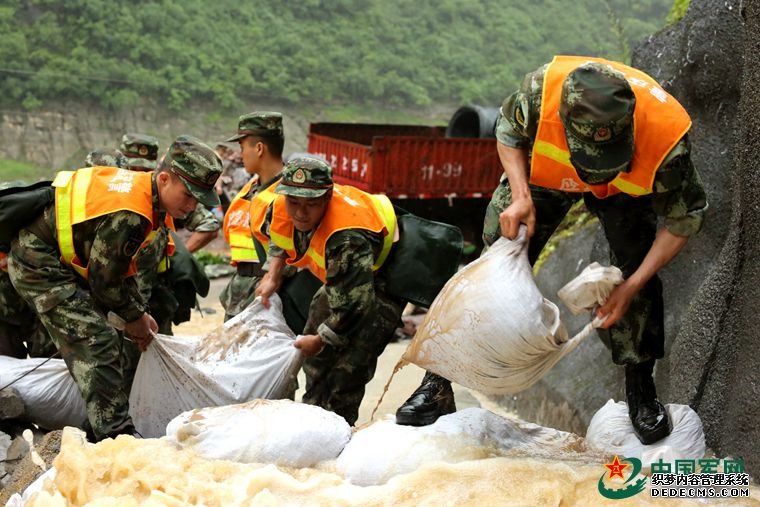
[161,135,222,207]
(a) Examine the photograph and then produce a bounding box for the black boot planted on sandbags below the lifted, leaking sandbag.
[396,372,457,426]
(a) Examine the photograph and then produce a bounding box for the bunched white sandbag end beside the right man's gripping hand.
[557,262,623,315]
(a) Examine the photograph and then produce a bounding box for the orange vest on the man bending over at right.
[530,56,691,198]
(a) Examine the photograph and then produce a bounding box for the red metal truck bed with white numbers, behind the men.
[308,123,502,199]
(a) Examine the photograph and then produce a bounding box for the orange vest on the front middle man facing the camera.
[251,185,396,283]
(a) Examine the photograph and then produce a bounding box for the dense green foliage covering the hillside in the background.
[0,0,672,110]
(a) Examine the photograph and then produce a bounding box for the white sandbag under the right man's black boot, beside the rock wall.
[586,400,706,467]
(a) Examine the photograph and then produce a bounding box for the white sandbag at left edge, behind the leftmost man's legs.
[0,356,87,430]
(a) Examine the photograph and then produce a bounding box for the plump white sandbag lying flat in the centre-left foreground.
[166,400,351,468]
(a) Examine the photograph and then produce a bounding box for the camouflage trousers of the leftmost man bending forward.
[8,229,140,440]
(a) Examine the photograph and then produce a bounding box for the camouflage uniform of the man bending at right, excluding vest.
[483,61,707,364]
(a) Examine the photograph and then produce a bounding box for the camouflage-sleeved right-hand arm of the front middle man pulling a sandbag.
[317,230,376,348]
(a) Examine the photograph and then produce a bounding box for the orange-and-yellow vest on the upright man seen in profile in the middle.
[223,177,279,266]
